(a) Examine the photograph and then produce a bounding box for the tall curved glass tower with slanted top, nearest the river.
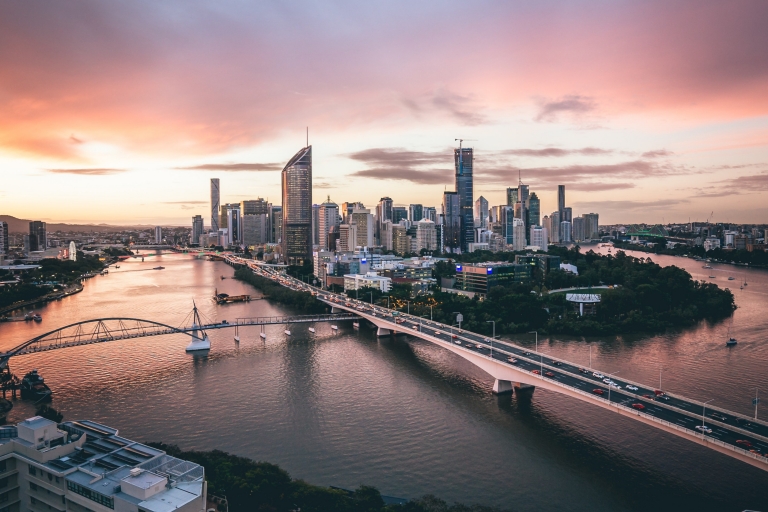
[282,146,312,265]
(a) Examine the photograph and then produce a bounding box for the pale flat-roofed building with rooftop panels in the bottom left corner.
[0,416,206,512]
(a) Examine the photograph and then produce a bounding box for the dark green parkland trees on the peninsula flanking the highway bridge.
[240,247,736,336]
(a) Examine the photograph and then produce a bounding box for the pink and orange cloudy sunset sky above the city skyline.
[0,0,768,226]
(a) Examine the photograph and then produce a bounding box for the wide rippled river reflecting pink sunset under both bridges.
[0,249,768,511]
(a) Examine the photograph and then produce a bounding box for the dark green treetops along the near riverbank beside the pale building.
[147,442,509,512]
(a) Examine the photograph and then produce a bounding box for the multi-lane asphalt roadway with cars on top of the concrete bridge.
[225,258,768,466]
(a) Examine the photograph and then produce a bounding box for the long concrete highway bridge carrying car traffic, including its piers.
[227,255,768,471]
